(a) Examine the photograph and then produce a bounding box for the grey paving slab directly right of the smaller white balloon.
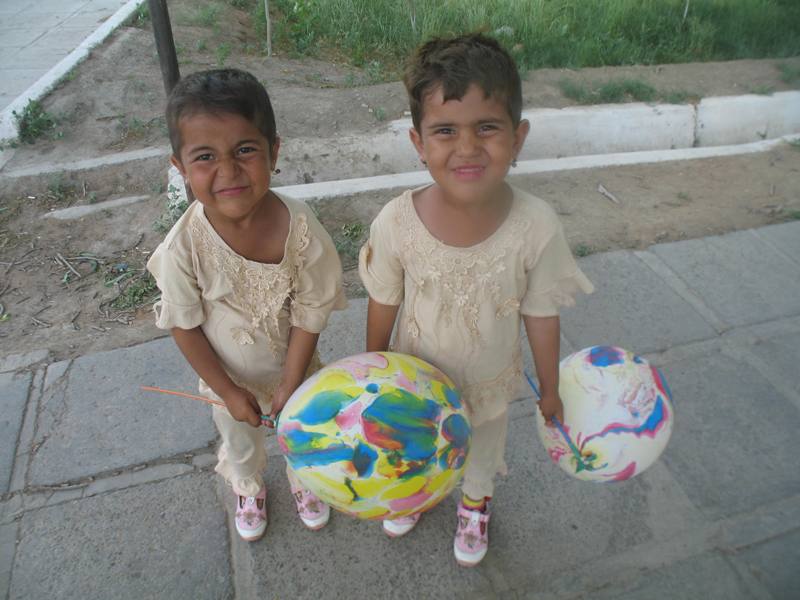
[662,352,800,519]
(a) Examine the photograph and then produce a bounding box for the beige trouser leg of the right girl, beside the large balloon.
[461,410,508,500]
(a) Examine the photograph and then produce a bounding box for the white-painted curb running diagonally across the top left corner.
[0,0,144,142]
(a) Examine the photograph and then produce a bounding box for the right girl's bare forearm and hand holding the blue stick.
[523,315,564,426]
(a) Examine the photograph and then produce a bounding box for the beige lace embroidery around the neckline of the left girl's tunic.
[190,213,309,357]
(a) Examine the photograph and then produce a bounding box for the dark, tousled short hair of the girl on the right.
[403,33,522,130]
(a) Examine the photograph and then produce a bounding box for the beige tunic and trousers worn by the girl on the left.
[147,198,347,496]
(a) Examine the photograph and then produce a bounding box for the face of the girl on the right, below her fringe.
[411,84,529,204]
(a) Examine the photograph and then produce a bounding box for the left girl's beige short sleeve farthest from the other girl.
[147,242,205,329]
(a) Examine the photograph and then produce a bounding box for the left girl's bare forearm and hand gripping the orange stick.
[172,327,261,427]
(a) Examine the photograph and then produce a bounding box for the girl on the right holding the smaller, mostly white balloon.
[359,35,592,566]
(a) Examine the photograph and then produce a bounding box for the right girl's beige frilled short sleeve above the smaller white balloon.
[520,224,594,317]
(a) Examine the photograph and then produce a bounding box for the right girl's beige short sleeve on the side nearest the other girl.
[358,205,404,306]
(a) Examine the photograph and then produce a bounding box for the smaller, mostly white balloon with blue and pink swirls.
[537,346,674,482]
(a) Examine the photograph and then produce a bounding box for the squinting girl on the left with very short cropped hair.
[147,69,345,541]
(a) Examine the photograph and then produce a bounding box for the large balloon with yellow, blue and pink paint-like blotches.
[277,352,471,519]
